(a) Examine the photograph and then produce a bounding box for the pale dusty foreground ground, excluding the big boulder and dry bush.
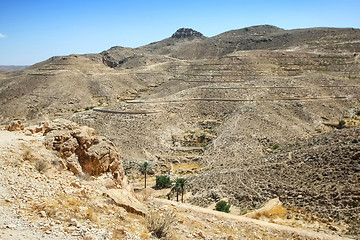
[0,131,352,240]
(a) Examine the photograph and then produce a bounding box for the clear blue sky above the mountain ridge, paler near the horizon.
[0,0,360,65]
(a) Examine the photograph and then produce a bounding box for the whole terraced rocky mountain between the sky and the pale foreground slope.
[0,25,360,236]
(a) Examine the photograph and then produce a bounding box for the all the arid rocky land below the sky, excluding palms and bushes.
[0,25,360,239]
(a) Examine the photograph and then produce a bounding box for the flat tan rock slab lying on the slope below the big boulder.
[105,189,147,216]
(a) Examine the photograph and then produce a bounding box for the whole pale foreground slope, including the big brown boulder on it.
[0,122,346,240]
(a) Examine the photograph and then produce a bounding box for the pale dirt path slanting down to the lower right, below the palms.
[154,199,349,240]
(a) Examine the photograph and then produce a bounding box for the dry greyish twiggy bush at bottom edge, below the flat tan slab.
[145,210,175,239]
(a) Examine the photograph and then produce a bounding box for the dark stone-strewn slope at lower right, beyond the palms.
[192,128,360,233]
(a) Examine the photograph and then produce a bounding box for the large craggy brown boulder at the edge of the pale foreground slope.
[43,119,126,185]
